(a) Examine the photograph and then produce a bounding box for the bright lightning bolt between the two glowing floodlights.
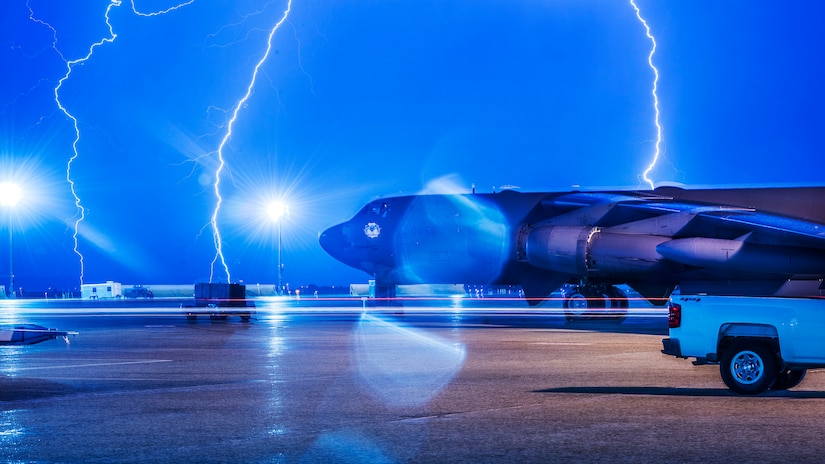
[209,0,292,283]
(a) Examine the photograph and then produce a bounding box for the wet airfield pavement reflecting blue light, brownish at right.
[0,299,825,463]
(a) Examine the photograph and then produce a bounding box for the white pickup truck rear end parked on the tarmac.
[662,295,825,395]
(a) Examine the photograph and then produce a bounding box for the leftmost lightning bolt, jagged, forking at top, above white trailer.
[26,0,195,285]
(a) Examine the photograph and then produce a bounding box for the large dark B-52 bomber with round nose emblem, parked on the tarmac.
[320,187,825,308]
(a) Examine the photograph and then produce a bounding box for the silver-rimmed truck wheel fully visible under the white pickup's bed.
[719,342,777,395]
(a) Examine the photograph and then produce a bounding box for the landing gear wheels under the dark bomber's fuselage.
[562,284,628,322]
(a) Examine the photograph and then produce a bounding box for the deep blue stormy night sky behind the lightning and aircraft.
[0,0,825,289]
